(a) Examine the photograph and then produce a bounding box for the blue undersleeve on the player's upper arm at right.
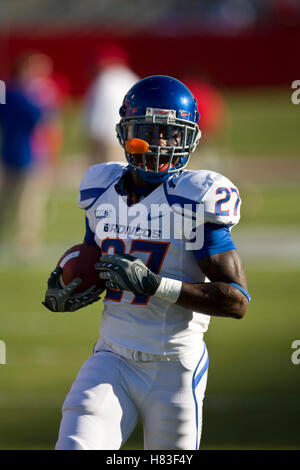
[194,223,236,260]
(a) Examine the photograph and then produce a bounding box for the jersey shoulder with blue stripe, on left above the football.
[78,162,127,209]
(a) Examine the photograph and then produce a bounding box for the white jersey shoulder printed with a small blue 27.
[166,170,241,226]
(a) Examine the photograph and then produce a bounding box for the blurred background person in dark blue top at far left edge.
[0,60,42,255]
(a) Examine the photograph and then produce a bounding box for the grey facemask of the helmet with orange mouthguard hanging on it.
[116,108,201,183]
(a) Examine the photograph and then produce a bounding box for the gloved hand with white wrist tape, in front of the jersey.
[95,254,161,295]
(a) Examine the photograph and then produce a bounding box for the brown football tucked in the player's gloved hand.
[57,243,105,292]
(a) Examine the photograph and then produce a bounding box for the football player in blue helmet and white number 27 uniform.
[45,76,250,450]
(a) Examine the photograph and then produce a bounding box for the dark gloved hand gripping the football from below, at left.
[42,267,104,312]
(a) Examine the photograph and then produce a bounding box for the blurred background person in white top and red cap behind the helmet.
[84,44,139,164]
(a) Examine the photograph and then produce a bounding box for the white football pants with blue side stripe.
[56,340,208,450]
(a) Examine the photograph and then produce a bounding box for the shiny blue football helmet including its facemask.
[116,75,201,183]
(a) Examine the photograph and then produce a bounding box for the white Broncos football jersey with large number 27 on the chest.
[79,163,240,355]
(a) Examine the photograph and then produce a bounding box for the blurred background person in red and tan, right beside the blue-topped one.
[16,53,67,258]
